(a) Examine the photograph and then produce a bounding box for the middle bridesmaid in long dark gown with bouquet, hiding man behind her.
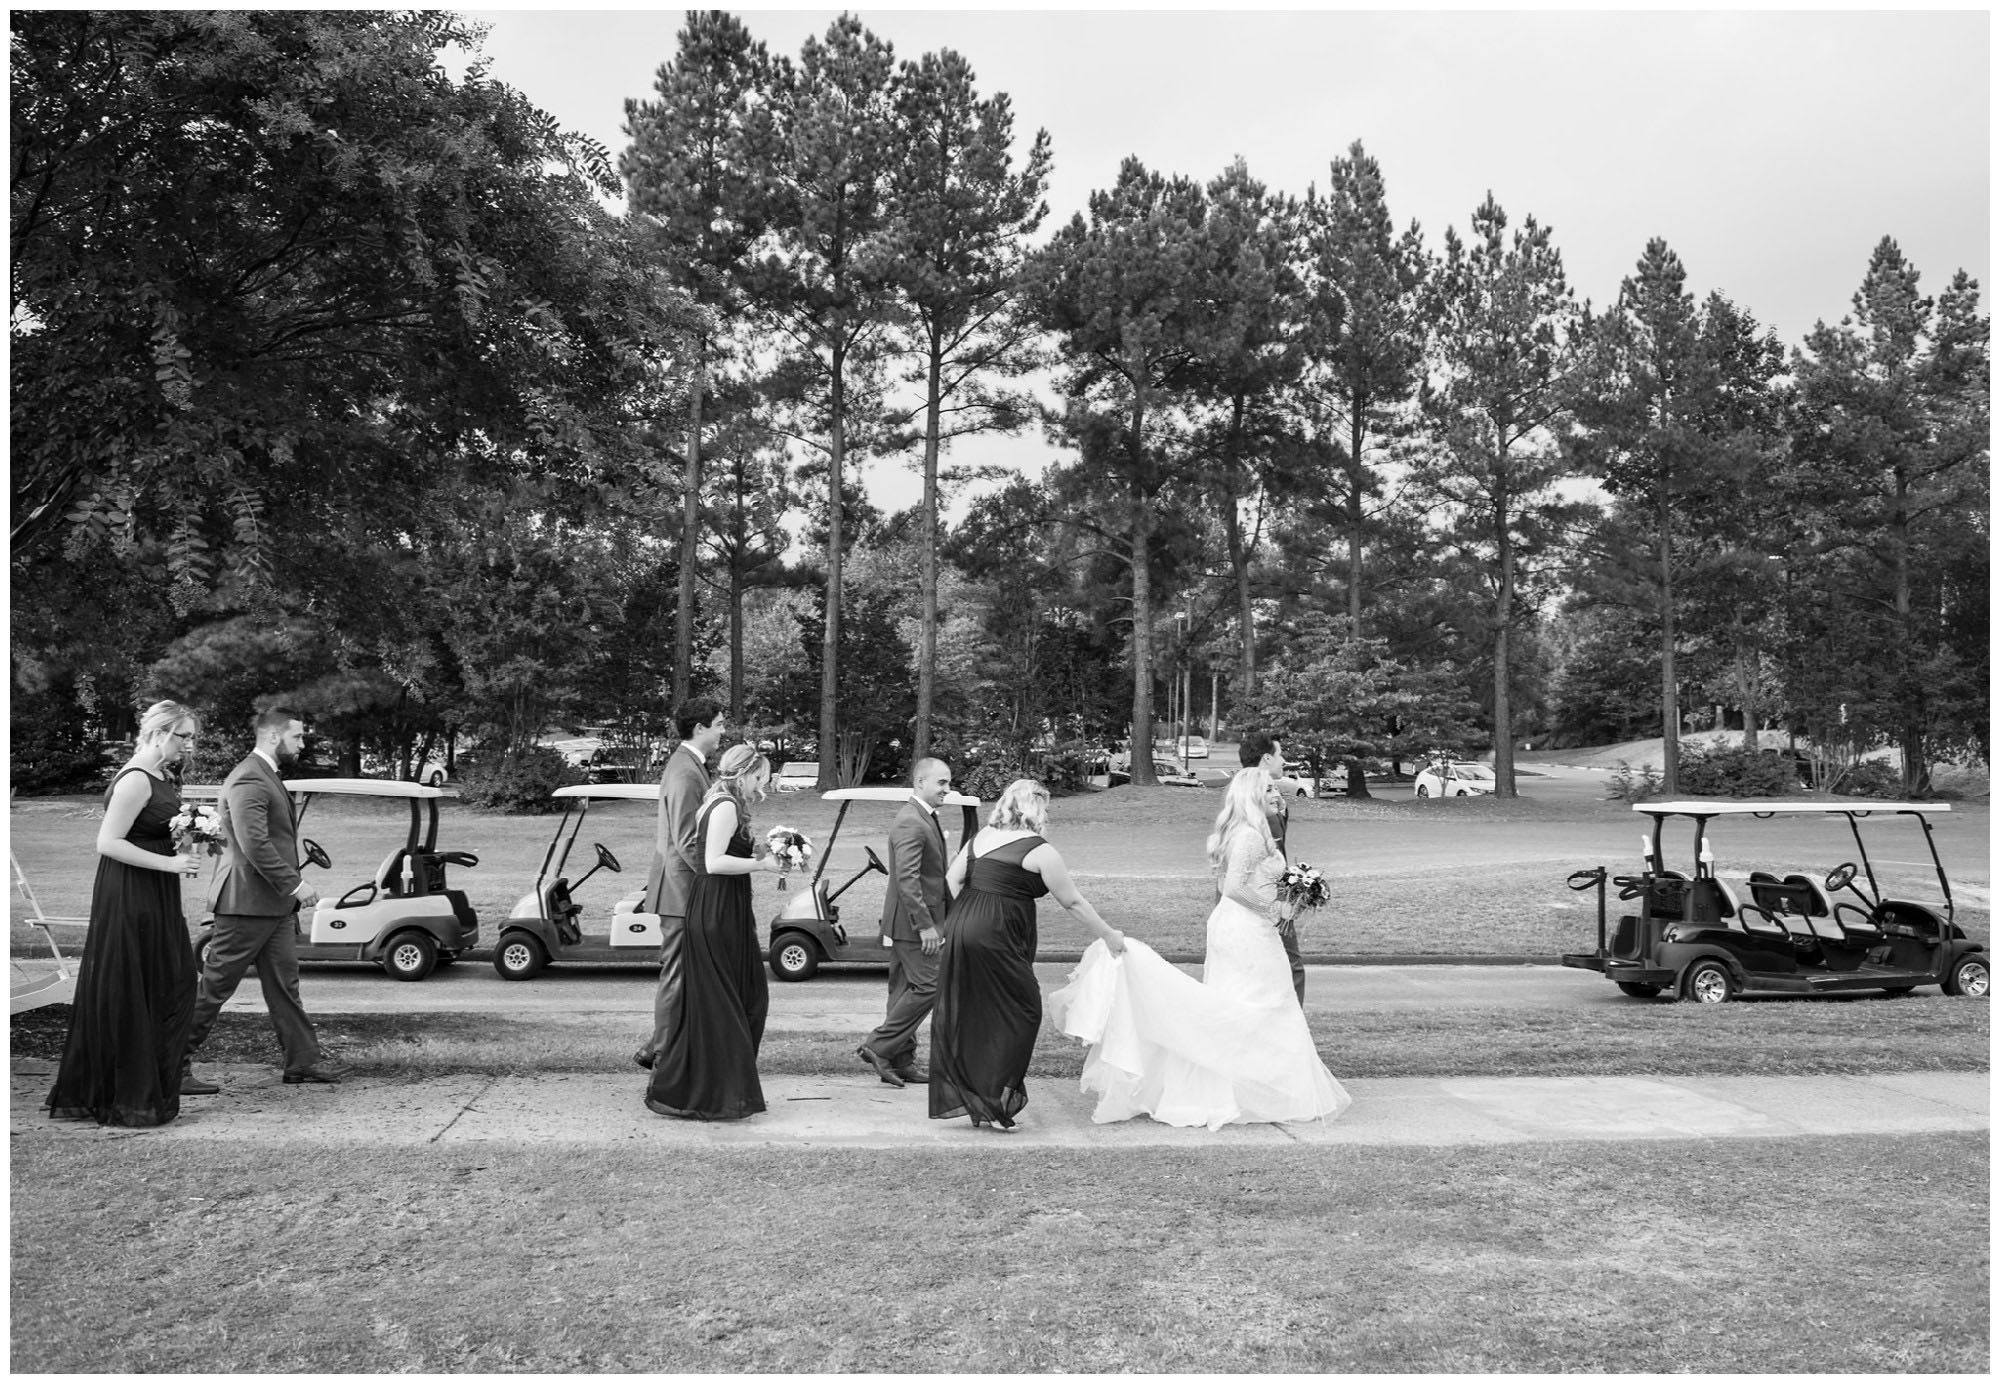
[646,744,780,1120]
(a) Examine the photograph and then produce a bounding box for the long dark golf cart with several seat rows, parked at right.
[1562,802,1988,1004]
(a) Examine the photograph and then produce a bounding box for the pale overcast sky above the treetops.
[474,6,1990,504]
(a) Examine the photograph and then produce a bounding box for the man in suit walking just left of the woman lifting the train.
[856,760,952,1086]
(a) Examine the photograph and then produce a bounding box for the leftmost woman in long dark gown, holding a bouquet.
[46,702,202,1128]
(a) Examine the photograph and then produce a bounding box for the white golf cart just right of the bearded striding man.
[194,778,480,980]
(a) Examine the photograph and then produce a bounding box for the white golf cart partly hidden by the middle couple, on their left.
[494,784,684,980]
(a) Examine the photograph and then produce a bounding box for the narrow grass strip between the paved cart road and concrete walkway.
[10,996,1992,1082]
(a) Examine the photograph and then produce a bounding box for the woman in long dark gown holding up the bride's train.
[930,778,1124,1130]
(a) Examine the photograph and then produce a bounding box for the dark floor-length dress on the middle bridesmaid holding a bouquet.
[646,802,770,1120]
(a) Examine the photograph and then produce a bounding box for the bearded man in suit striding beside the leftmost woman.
[180,706,342,1096]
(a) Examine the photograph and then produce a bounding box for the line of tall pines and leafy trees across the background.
[10,12,1990,794]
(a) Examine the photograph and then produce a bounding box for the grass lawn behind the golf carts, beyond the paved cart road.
[10,788,1990,960]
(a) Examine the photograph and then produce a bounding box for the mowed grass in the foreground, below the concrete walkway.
[10,1134,1990,1374]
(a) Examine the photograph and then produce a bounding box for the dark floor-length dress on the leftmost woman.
[46,768,198,1128]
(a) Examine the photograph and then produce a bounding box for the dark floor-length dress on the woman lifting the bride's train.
[930,836,1048,1128]
